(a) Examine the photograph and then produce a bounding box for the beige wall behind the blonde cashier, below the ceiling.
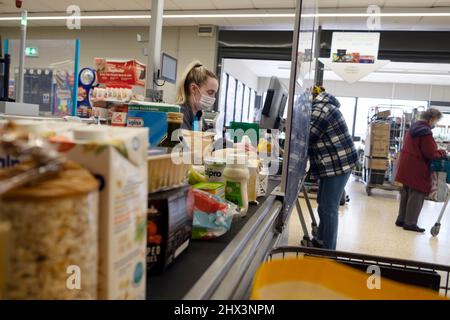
[0,27,217,103]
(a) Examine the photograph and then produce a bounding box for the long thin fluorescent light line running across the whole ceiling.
[0,12,450,21]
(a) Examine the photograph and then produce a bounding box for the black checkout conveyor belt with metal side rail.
[147,179,282,300]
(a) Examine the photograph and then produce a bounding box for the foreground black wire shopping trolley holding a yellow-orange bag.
[251,247,450,300]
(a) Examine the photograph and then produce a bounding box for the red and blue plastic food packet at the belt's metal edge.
[192,189,238,240]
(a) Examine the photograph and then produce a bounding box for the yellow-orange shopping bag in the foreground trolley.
[251,257,444,300]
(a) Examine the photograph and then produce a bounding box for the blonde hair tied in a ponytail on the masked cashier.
[176,60,218,105]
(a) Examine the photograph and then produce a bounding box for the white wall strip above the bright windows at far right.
[324,80,450,101]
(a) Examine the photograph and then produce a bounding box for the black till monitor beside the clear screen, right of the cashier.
[259,77,288,129]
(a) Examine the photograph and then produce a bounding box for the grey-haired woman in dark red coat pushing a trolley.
[395,108,446,232]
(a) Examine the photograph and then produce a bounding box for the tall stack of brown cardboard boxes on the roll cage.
[364,122,391,184]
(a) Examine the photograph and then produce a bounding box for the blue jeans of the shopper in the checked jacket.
[317,173,350,250]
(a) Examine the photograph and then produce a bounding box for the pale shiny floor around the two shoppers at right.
[288,178,450,265]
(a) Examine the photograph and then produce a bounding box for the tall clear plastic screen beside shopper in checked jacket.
[281,0,318,223]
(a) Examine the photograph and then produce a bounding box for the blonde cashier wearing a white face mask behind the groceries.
[176,61,219,131]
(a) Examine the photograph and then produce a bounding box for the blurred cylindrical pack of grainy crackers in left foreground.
[0,162,99,299]
